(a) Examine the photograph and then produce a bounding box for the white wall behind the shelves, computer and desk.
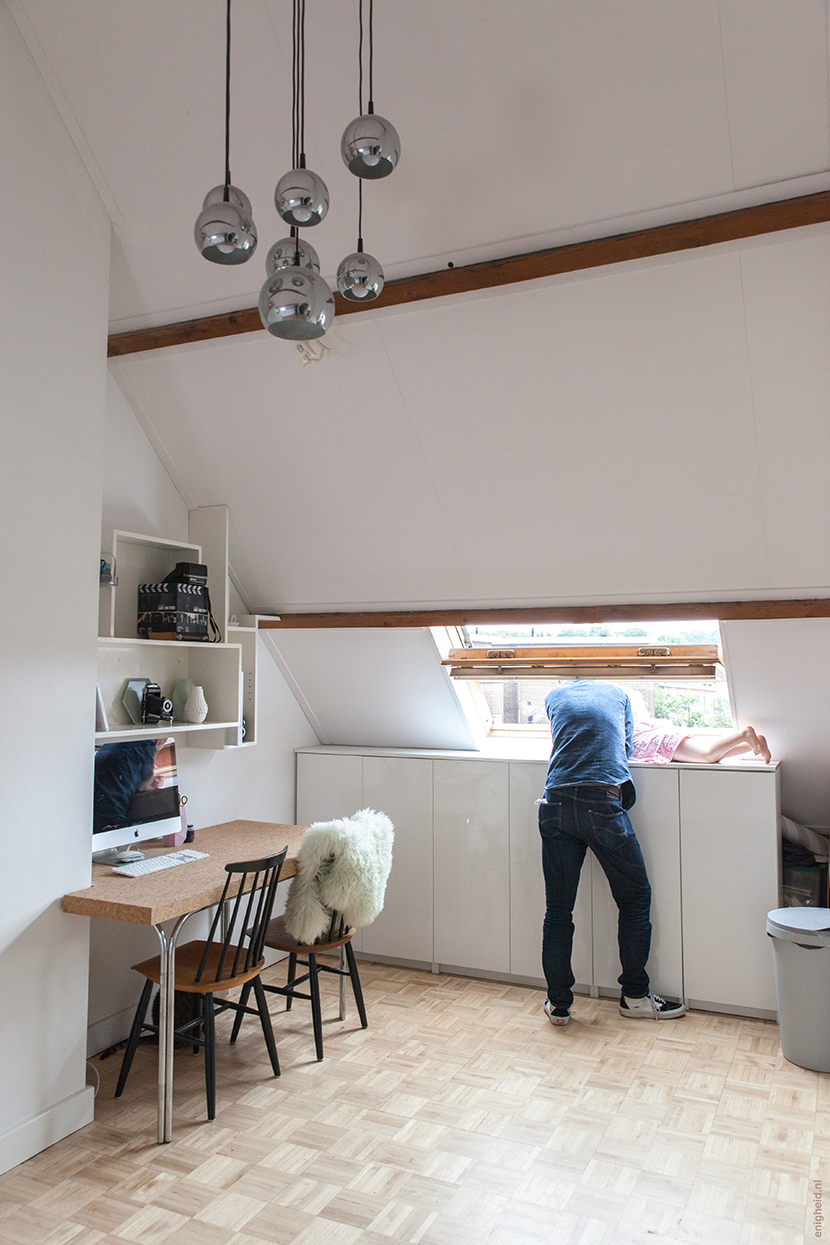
[87,377,317,1053]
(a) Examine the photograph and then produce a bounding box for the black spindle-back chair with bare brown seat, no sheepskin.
[116,848,287,1119]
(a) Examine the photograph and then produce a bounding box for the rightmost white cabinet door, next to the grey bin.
[681,767,780,1012]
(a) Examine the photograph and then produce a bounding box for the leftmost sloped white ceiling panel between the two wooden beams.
[113,322,468,611]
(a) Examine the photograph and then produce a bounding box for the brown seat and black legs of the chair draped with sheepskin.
[230,913,368,1061]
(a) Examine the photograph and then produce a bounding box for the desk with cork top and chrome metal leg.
[63,820,306,1144]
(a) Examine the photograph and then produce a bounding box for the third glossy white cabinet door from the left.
[433,759,510,972]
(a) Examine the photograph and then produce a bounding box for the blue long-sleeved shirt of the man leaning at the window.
[545,680,633,791]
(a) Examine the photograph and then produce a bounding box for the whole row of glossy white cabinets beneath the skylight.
[297,748,780,1016]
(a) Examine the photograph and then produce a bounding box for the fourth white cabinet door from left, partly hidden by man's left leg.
[510,761,592,990]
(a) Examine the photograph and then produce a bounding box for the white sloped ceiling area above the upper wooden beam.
[11,0,829,329]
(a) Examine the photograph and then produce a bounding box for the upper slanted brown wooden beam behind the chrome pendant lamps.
[107,190,830,359]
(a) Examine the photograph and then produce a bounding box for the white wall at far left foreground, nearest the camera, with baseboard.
[0,4,110,1170]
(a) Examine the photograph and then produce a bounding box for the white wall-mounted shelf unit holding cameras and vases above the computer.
[96,505,256,748]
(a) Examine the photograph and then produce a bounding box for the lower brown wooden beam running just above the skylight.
[259,596,830,630]
